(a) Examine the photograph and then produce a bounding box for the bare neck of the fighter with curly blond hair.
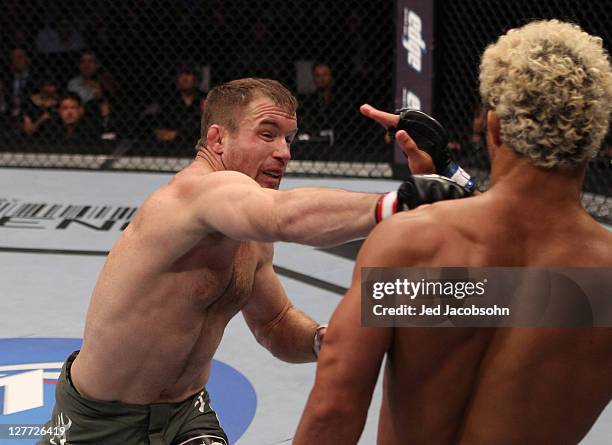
[490,147,584,208]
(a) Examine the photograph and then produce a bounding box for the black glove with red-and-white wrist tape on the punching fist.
[376,175,472,223]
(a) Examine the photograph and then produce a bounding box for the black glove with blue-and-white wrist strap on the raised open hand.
[387,108,476,191]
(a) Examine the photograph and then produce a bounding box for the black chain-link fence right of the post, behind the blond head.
[434,0,612,223]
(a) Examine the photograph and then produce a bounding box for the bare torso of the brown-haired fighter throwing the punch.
[72,166,271,404]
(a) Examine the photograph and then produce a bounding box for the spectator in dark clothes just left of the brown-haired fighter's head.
[153,63,203,154]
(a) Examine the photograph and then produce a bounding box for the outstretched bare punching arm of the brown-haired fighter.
[192,171,379,246]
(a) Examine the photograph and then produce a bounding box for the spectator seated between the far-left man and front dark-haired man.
[22,72,59,136]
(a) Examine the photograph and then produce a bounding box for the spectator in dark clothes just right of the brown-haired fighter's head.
[300,62,343,142]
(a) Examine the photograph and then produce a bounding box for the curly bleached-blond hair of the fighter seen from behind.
[480,20,612,169]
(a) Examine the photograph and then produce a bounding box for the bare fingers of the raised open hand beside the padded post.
[359,104,436,175]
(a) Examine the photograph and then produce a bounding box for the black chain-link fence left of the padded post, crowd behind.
[0,0,394,176]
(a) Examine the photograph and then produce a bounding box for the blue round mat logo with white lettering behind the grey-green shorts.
[0,338,257,444]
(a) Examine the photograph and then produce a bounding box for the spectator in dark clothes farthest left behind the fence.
[3,47,34,126]
